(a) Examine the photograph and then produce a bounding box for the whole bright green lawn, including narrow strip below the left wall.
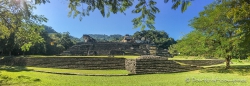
[0,64,250,86]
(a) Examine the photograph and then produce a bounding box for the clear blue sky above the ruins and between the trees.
[34,0,214,39]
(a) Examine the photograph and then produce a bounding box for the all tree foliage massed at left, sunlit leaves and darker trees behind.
[0,0,80,55]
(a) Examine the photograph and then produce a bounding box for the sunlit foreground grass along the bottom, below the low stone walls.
[1,71,250,86]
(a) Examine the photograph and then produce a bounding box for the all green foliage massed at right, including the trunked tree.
[172,0,250,68]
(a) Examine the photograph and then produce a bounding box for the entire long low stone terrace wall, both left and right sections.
[0,55,225,74]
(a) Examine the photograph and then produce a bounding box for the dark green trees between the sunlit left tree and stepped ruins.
[26,29,79,55]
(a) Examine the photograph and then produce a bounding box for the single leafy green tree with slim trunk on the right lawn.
[190,2,246,69]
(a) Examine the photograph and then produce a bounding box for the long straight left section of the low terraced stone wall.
[0,57,125,70]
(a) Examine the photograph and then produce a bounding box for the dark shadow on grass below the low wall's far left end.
[0,65,32,72]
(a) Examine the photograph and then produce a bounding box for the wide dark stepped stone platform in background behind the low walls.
[62,42,149,56]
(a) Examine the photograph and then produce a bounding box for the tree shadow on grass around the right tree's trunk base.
[200,65,250,76]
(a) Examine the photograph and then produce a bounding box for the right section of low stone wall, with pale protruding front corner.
[125,55,225,74]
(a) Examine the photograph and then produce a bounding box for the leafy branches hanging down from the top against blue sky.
[28,0,190,30]
